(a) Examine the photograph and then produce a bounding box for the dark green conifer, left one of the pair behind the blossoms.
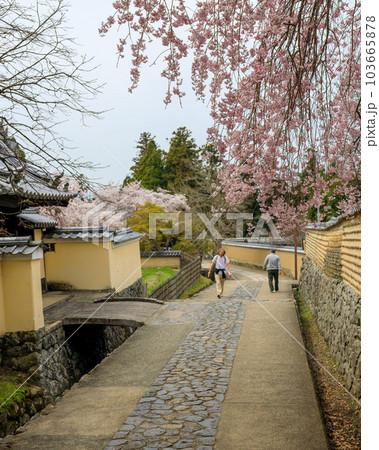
[123,132,167,190]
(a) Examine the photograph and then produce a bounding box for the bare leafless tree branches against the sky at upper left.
[0,0,101,186]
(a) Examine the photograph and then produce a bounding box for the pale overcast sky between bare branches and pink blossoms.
[59,0,211,183]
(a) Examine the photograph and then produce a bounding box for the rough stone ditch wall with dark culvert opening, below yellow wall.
[0,321,135,401]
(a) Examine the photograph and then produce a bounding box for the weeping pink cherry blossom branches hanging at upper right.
[100,0,361,236]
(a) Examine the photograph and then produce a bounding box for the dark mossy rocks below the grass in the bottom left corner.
[0,386,46,438]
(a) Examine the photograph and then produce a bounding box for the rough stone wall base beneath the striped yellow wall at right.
[300,258,361,397]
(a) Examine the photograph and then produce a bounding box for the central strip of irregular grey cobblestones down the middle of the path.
[106,282,258,450]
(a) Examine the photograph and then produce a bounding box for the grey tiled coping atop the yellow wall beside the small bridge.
[44,227,142,245]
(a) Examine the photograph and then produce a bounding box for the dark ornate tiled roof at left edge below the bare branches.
[0,139,77,201]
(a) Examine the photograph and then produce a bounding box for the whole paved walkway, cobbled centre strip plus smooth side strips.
[0,266,328,450]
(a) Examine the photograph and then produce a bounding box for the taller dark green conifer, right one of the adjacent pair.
[164,127,201,191]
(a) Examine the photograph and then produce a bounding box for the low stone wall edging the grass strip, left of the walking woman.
[149,257,201,300]
